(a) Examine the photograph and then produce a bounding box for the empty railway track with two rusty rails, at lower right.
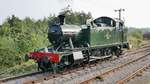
[81,52,150,84]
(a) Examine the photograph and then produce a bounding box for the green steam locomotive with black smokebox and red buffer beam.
[29,14,128,71]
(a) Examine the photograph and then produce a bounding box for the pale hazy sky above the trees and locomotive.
[0,0,150,28]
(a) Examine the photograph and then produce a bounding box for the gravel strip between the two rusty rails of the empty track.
[92,55,150,84]
